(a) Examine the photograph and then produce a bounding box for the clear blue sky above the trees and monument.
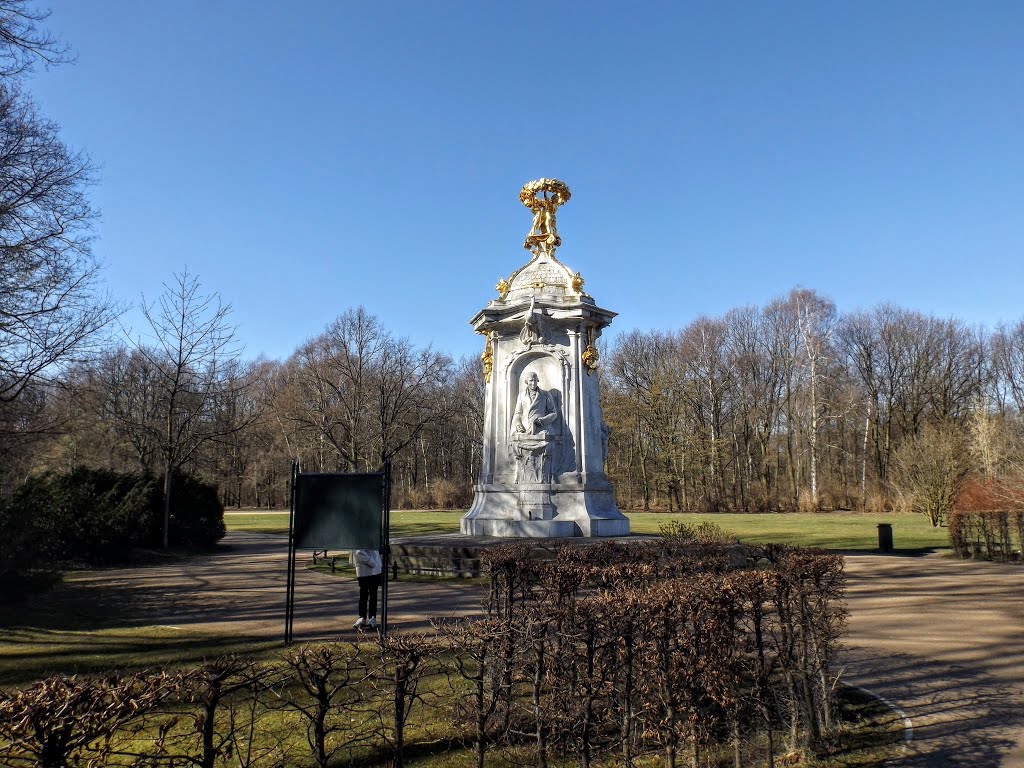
[26,0,1024,358]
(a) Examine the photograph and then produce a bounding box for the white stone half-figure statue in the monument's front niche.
[509,371,562,483]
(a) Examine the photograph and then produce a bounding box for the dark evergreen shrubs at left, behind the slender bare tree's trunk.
[0,467,225,577]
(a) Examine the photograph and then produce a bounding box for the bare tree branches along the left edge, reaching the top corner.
[0,0,116,493]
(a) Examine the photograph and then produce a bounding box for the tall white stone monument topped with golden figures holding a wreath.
[462,178,630,538]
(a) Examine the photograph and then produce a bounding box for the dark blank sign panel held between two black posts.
[295,472,384,549]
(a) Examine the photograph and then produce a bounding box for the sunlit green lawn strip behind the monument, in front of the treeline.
[224,510,949,553]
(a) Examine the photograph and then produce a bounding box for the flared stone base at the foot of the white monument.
[460,483,630,539]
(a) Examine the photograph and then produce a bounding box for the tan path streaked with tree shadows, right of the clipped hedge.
[846,554,1024,768]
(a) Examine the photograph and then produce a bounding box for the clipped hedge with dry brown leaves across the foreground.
[0,544,847,768]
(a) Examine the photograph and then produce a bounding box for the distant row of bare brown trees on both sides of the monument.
[0,290,1024,520]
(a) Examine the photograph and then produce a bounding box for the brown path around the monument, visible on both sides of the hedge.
[37,534,1024,768]
